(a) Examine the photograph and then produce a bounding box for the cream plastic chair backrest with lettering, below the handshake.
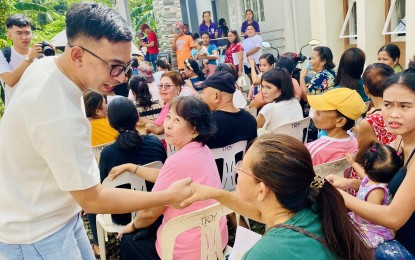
[160,203,233,260]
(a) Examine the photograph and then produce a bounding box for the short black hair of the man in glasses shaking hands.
[66,3,133,43]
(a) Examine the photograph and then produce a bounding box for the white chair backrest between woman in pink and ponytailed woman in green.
[210,140,248,191]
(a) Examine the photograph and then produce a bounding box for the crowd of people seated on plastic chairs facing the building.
[76,19,415,259]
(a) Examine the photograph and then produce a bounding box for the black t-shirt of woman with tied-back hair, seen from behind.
[99,135,167,225]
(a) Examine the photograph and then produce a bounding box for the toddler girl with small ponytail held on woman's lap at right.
[346,143,402,248]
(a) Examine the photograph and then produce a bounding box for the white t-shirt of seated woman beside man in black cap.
[259,98,303,140]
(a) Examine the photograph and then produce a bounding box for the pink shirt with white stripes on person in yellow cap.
[305,136,358,166]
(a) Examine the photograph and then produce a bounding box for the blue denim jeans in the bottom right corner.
[375,240,415,260]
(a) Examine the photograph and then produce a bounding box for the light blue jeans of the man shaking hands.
[0,214,95,260]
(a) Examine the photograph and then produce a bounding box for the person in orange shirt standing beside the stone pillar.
[171,22,195,70]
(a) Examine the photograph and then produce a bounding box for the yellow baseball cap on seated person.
[307,88,366,120]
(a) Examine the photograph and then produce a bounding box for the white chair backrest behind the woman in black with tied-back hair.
[102,161,163,225]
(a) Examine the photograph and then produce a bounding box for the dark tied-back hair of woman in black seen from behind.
[108,97,143,149]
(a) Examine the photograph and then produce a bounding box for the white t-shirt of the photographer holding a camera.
[0,46,27,106]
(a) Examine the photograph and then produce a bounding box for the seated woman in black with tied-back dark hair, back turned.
[88,97,167,254]
